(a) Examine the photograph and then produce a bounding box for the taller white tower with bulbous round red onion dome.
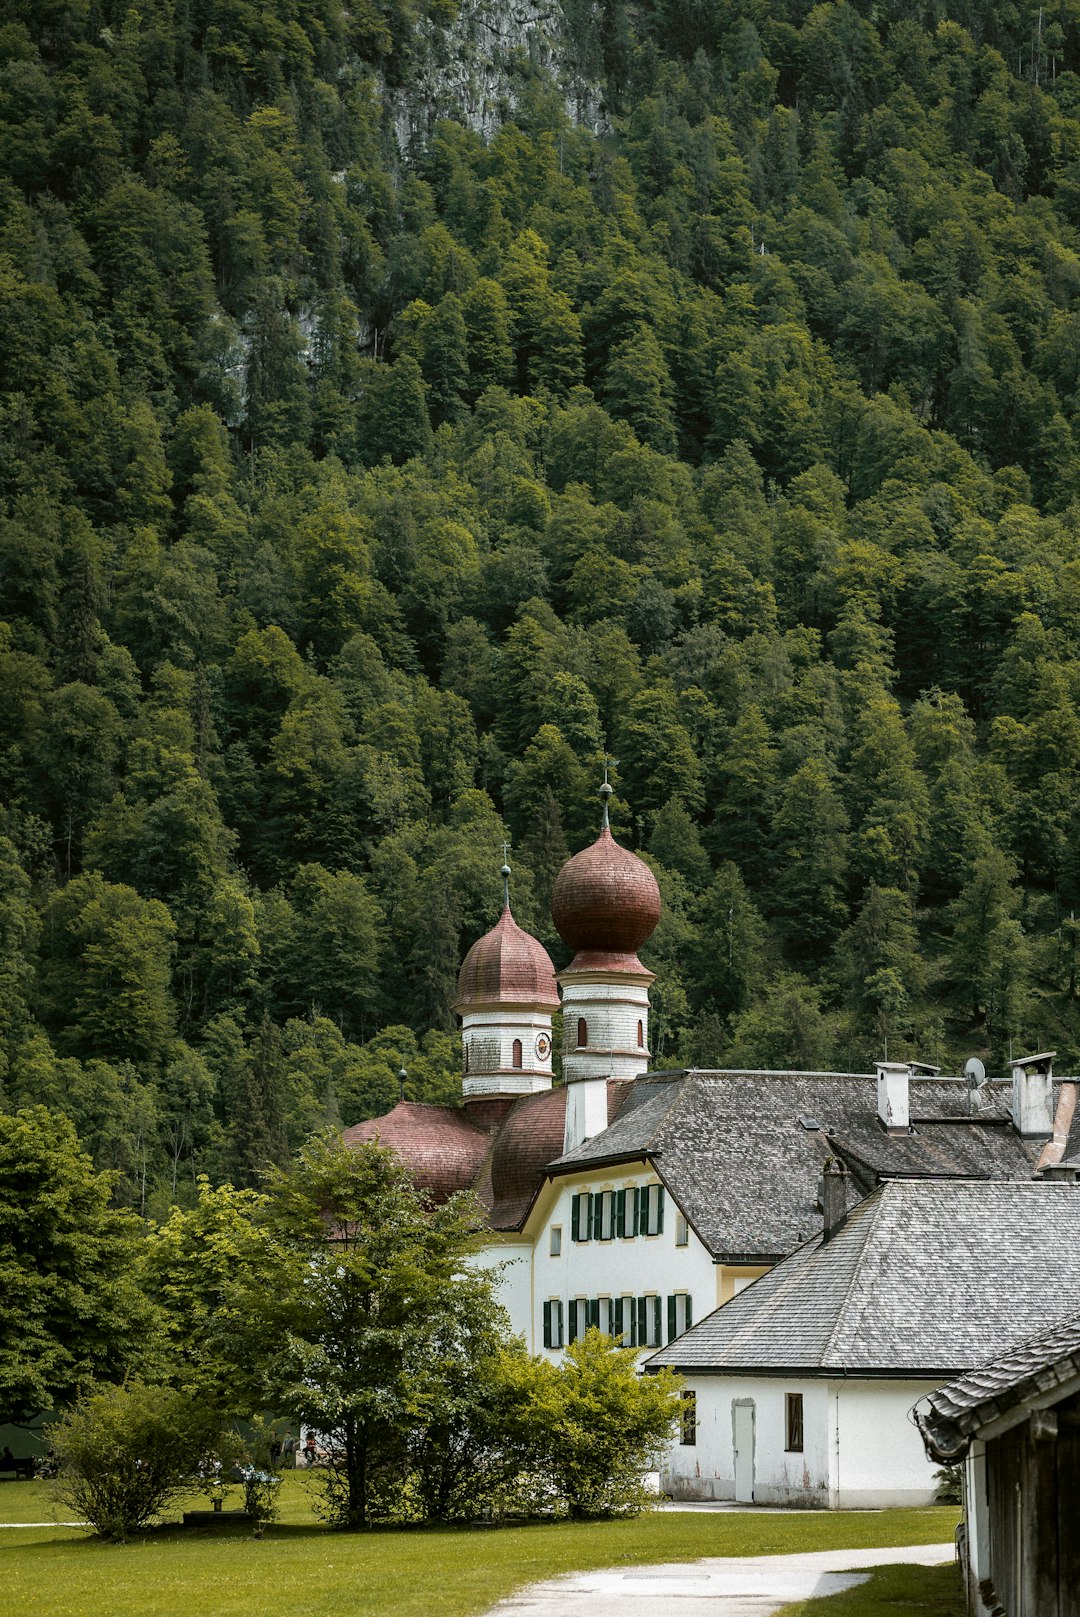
[551,779,660,1151]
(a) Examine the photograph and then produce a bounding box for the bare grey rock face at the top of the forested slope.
[386,0,606,154]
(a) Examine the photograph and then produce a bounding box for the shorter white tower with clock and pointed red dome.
[454,865,559,1101]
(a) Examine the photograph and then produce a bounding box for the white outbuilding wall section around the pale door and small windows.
[660,1376,829,1509]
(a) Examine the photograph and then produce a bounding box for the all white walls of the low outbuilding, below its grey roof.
[660,1374,941,1510]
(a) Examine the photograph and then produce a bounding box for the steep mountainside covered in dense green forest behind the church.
[0,0,1080,1210]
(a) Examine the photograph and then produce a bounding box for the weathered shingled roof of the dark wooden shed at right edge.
[918,1300,1080,1462]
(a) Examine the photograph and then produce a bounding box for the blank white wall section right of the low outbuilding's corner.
[833,1379,941,1510]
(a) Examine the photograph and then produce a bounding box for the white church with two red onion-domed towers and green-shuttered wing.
[344,783,1080,1377]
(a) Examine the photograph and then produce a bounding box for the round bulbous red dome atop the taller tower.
[551,825,660,964]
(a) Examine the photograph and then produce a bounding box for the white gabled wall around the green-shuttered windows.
[534,1169,716,1360]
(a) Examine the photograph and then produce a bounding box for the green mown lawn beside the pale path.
[0,1475,957,1617]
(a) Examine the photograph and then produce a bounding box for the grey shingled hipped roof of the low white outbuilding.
[648,1180,1080,1376]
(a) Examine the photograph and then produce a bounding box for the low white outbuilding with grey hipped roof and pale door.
[645,1164,1080,1509]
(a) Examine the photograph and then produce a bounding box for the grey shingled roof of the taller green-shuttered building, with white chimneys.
[548,1070,1054,1263]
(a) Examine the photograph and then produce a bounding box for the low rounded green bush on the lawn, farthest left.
[49,1383,221,1543]
